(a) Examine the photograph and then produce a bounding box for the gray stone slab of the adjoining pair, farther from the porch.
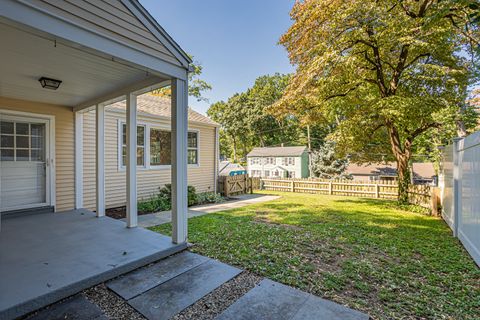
[128,259,241,320]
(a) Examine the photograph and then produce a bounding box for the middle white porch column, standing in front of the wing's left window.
[127,93,137,228]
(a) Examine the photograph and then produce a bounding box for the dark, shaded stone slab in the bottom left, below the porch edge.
[28,294,108,320]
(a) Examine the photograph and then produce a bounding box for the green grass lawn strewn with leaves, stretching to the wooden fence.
[152,193,480,319]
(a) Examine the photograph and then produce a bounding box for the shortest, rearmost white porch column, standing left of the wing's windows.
[95,104,105,217]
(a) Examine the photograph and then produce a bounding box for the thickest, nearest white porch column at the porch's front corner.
[171,79,188,243]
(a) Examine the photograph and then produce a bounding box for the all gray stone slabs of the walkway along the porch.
[31,251,369,320]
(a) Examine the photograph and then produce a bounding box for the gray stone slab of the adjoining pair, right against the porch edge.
[107,251,209,300]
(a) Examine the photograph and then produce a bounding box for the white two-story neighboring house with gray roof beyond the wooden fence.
[247,147,309,178]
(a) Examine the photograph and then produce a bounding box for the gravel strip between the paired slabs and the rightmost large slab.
[172,271,263,320]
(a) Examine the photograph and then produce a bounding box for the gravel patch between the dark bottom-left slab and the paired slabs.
[83,284,146,320]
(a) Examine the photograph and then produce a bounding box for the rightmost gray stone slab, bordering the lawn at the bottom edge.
[216,279,369,320]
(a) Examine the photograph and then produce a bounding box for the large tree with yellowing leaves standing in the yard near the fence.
[275,0,479,202]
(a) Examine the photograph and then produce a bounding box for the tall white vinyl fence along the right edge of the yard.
[443,132,480,266]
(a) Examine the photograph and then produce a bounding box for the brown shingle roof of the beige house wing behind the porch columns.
[107,93,219,126]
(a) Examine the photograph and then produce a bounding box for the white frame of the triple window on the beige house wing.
[117,119,201,171]
